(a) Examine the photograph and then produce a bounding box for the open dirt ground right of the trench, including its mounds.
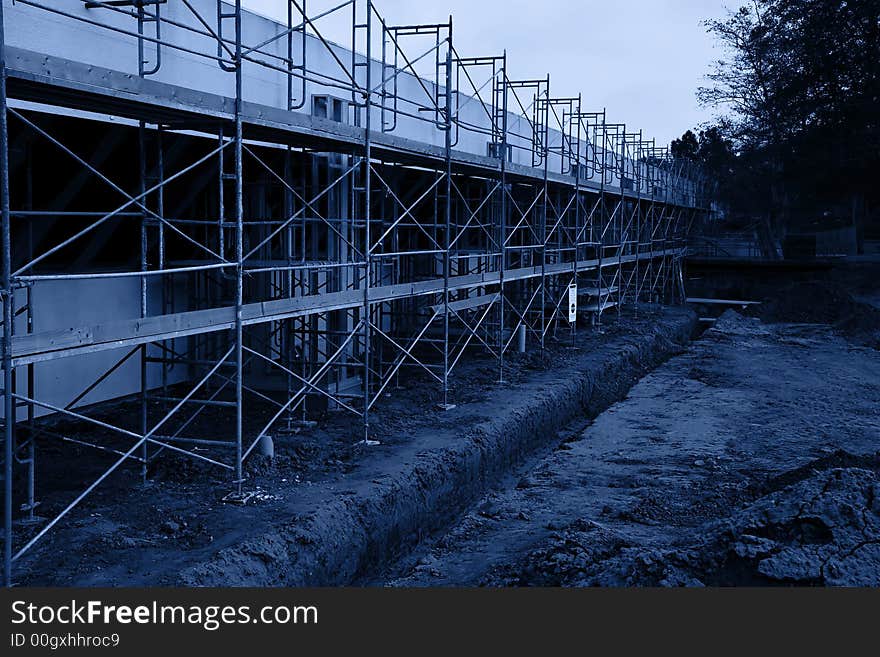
[384,302,880,586]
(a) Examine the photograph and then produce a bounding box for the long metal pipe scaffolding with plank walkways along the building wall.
[0,0,710,584]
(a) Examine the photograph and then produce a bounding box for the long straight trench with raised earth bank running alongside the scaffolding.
[177,308,696,586]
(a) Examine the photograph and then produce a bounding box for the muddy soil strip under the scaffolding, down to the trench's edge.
[6,307,694,586]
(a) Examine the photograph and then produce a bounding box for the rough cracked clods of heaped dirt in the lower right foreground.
[482,452,880,586]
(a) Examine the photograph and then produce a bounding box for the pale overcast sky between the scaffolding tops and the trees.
[242,0,739,144]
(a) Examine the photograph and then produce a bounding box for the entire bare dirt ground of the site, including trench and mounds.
[8,270,880,586]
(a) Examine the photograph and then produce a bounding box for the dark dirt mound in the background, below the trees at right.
[746,281,880,349]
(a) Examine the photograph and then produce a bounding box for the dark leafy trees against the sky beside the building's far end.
[672,0,880,237]
